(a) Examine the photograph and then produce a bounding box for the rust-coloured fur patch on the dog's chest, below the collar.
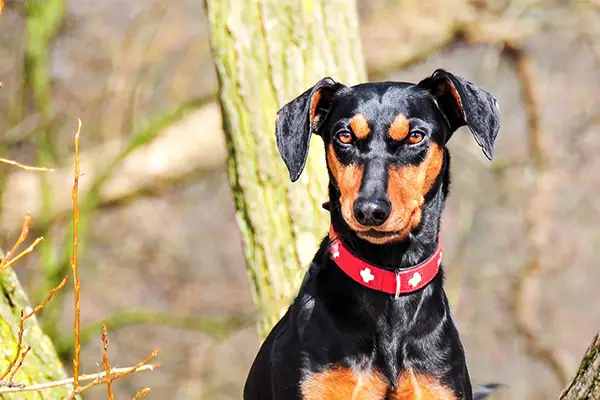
[301,366,456,400]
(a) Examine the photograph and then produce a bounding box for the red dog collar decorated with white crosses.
[329,226,442,298]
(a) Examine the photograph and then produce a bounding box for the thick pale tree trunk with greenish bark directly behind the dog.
[206,0,365,335]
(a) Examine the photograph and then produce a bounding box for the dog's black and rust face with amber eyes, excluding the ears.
[321,84,448,243]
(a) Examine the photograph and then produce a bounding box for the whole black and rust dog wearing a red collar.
[244,70,499,400]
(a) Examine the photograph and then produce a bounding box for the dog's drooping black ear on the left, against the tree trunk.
[275,78,344,182]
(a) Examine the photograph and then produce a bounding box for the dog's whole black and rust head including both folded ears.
[276,70,499,244]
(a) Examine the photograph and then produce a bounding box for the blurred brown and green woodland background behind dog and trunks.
[0,0,600,399]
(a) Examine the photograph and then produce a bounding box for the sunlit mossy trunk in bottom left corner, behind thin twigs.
[0,268,71,400]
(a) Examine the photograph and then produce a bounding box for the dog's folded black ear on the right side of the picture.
[419,69,500,160]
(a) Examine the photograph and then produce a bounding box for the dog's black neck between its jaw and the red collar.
[329,151,450,270]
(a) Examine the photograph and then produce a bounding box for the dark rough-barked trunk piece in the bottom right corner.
[560,333,600,400]
